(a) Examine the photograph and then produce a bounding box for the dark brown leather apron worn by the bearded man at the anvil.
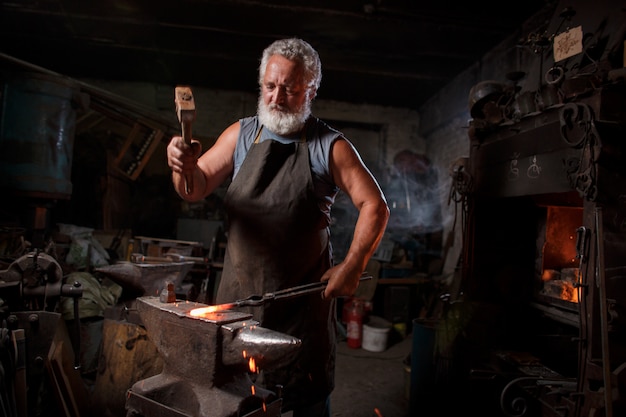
[216,128,336,410]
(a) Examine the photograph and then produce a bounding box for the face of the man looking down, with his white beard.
[258,55,311,135]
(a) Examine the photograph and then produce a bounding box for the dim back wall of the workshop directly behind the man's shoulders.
[72,79,426,249]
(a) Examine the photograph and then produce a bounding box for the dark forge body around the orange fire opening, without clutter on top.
[456,83,626,417]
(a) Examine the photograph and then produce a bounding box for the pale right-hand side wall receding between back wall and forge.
[418,8,553,282]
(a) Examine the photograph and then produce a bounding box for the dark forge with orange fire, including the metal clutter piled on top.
[444,2,626,417]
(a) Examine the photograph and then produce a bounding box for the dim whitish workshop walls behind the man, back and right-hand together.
[42,0,543,277]
